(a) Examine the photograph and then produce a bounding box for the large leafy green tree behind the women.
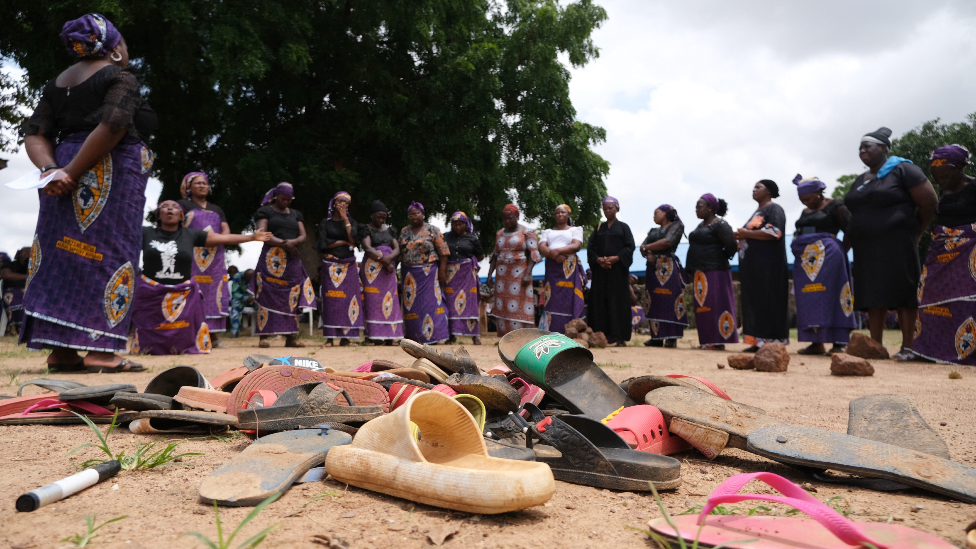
[0,0,609,253]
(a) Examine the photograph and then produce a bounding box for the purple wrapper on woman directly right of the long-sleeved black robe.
[644,254,688,339]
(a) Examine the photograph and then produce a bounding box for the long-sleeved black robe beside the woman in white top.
[586,220,635,342]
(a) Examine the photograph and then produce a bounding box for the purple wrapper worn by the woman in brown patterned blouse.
[402,263,450,343]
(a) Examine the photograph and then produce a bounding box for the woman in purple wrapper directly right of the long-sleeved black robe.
[640,204,688,349]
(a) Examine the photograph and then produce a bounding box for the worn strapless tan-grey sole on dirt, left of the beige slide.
[200,429,352,507]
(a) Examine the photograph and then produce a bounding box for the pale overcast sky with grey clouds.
[0,0,976,267]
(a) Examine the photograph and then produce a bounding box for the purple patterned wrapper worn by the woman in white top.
[539,254,586,334]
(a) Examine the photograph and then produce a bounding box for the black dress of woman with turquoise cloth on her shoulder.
[844,162,925,311]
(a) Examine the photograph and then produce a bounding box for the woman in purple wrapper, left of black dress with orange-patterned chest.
[685,193,739,351]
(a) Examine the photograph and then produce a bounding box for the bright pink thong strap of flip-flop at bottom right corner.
[698,473,887,549]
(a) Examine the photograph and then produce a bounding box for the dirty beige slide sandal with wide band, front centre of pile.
[325,391,556,514]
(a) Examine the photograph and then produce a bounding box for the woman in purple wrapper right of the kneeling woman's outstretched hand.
[248,183,316,348]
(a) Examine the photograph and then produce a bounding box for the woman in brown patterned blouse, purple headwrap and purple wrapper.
[400,202,451,343]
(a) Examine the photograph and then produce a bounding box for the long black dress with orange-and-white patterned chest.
[739,204,790,343]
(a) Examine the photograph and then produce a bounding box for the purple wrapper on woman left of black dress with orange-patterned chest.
[692,271,739,345]
